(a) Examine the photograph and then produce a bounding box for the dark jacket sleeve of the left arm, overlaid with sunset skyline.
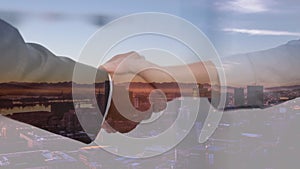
[0,19,110,143]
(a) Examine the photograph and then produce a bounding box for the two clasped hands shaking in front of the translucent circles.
[100,52,219,133]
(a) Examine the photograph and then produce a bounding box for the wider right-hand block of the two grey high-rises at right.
[247,86,264,107]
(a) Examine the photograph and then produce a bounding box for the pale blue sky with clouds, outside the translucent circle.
[0,0,300,60]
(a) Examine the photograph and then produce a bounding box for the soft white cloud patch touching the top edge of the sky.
[215,0,270,13]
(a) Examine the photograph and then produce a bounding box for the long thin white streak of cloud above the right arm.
[223,28,300,36]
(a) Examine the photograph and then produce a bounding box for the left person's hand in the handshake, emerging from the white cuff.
[100,52,167,133]
